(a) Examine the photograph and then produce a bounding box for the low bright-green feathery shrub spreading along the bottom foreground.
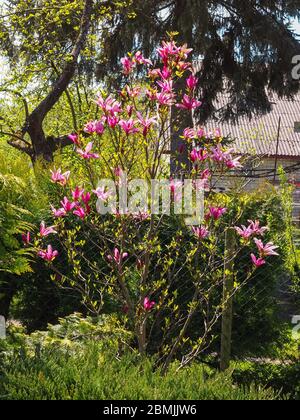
[0,342,279,400]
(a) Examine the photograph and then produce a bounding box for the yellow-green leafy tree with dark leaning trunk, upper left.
[0,0,134,161]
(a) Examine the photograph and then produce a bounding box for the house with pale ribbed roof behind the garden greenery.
[206,94,300,222]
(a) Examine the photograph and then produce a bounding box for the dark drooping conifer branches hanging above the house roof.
[99,0,300,121]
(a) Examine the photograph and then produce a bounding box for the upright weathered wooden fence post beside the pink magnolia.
[220,229,236,371]
